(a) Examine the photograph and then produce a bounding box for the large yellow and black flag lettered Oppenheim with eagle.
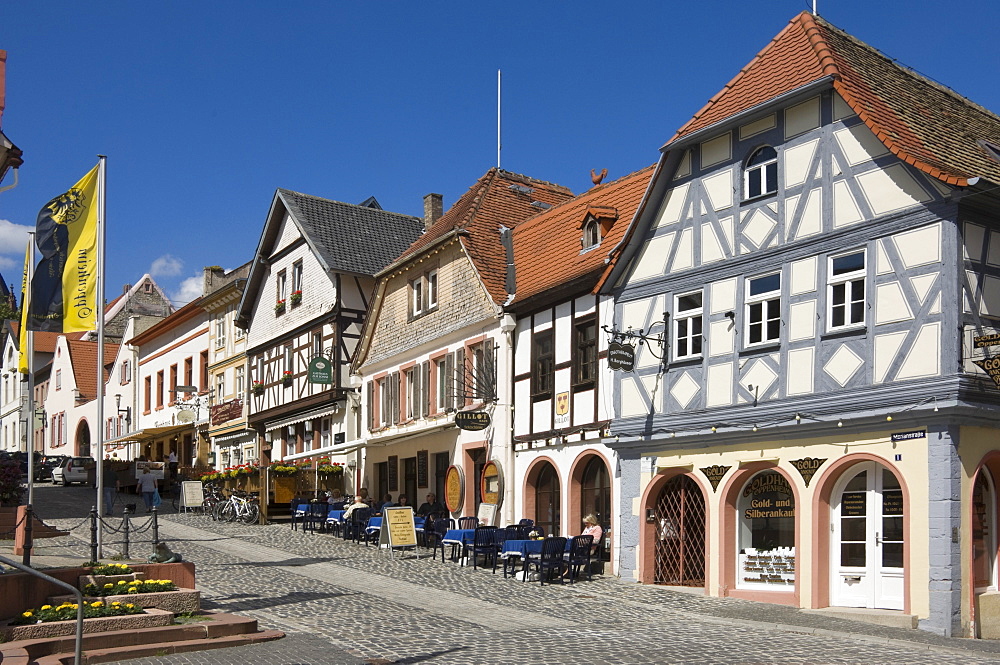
[27,165,100,333]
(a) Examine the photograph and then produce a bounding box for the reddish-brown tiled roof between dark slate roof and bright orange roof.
[390,168,573,304]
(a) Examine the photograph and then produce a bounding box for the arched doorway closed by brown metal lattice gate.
[653,476,705,587]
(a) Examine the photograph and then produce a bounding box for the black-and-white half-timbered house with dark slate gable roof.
[236,189,422,490]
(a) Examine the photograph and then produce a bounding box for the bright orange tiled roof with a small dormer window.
[512,166,655,307]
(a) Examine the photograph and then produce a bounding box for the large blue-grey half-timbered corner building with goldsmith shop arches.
[609,13,1000,634]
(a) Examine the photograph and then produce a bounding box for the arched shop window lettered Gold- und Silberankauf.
[736,471,795,590]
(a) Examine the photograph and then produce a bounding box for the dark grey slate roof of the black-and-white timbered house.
[277,188,424,275]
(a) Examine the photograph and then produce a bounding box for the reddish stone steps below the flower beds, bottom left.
[0,613,284,665]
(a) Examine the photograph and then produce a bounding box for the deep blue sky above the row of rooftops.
[0,0,1000,303]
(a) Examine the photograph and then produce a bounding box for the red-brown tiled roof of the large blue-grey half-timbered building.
[664,12,1000,187]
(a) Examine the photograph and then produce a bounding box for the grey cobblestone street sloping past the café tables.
[11,485,1000,665]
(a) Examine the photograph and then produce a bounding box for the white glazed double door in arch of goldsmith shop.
[830,462,905,610]
